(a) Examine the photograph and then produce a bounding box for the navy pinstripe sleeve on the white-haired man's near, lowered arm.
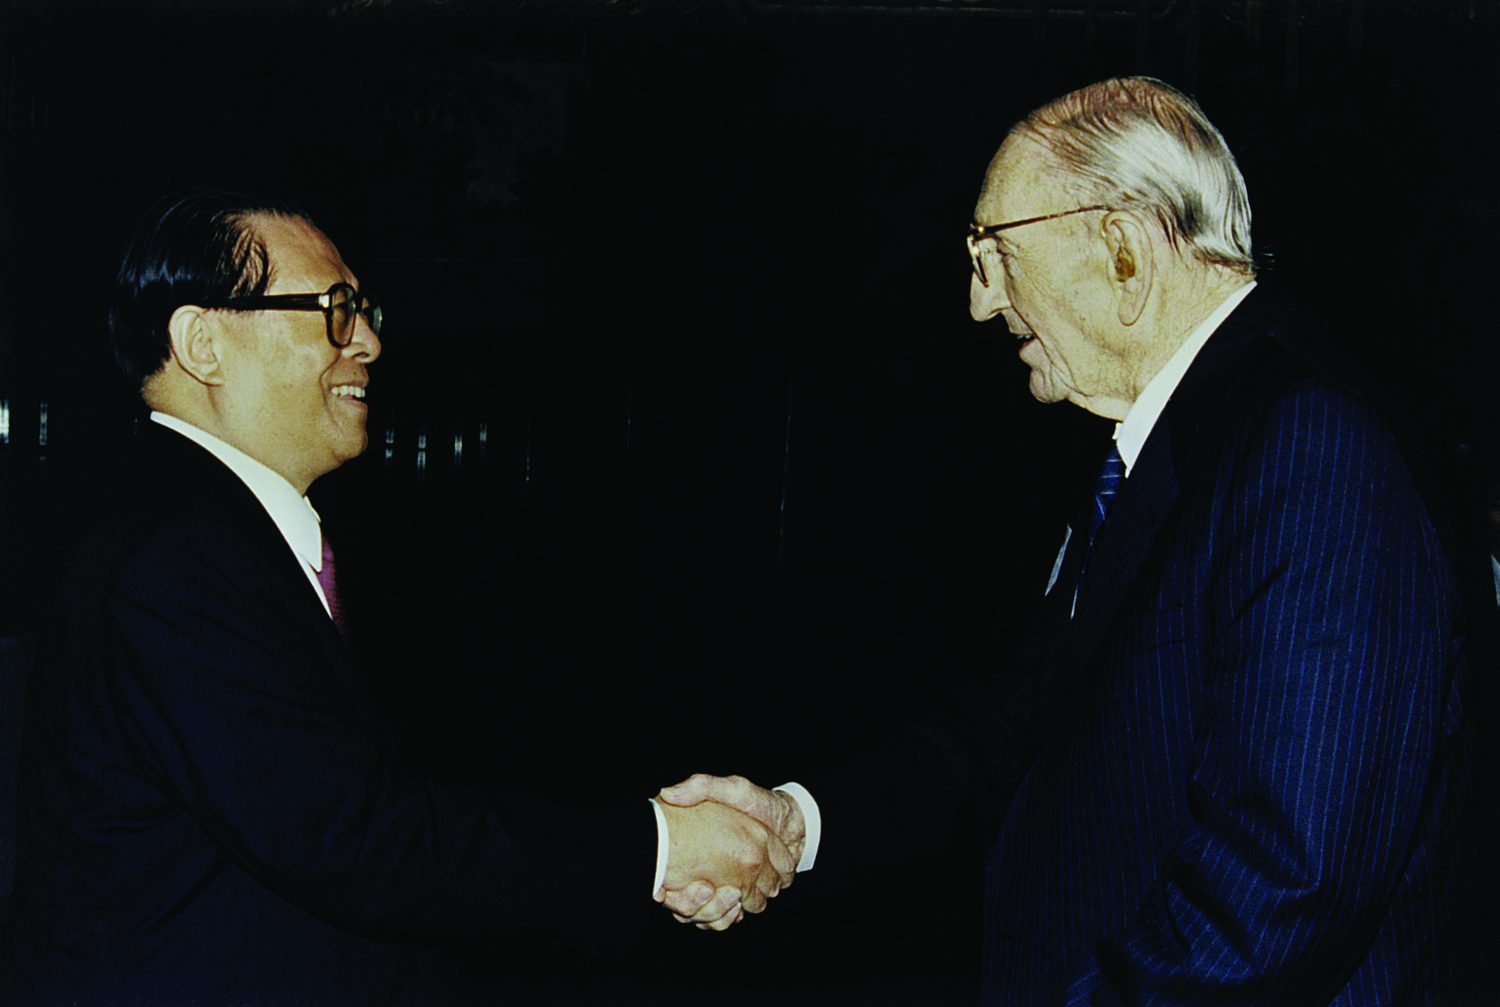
[1065,390,1458,1004]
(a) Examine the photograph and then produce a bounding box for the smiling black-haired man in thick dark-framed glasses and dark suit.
[12,192,794,1005]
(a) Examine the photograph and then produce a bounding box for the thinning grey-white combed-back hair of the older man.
[1017,77,1256,275]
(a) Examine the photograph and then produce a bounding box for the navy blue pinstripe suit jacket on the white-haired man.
[983,296,1467,1004]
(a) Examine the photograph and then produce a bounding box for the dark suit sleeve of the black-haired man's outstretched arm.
[105,521,656,936]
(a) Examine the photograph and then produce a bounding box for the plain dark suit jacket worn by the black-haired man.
[12,425,656,1007]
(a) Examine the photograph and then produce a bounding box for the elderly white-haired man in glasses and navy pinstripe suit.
[665,78,1469,1004]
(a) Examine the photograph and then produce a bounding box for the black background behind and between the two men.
[0,0,1500,1004]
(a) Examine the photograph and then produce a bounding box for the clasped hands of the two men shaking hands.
[656,773,807,930]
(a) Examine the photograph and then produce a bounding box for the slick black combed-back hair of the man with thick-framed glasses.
[110,189,309,386]
